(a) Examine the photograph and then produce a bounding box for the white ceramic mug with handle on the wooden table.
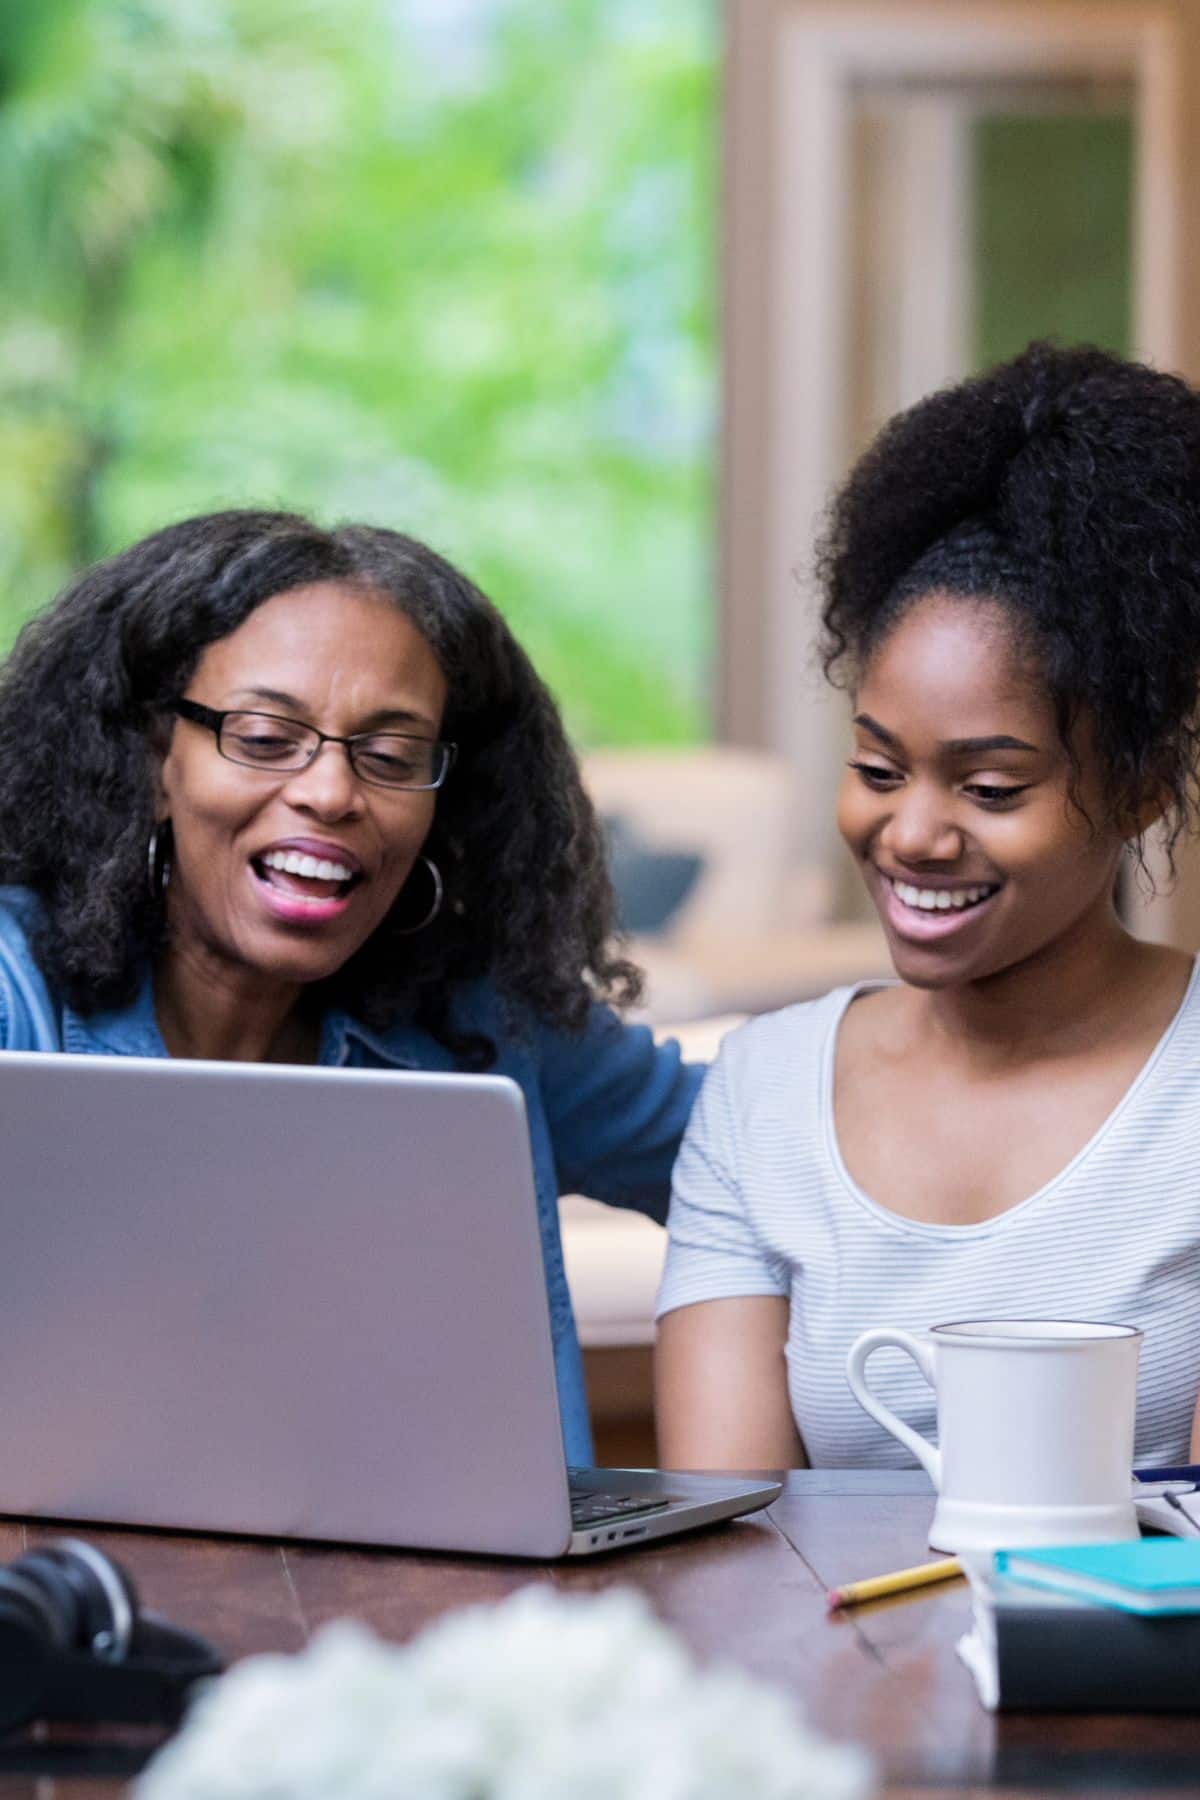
[846,1319,1142,1552]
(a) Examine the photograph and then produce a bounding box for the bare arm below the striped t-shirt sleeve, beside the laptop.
[655,1294,806,1469]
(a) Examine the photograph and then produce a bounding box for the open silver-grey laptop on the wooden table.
[0,1053,779,1557]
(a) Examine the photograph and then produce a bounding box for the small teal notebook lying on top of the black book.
[995,1537,1200,1613]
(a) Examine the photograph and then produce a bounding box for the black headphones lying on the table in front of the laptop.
[0,1537,223,1732]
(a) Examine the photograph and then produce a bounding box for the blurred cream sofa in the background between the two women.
[561,747,891,1463]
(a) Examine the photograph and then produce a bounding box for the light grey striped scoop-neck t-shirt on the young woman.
[658,968,1200,1469]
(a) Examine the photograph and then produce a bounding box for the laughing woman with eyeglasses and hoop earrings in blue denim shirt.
[0,511,700,1463]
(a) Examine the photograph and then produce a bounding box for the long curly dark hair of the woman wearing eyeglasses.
[0,511,640,1066]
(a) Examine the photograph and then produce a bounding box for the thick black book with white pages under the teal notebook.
[959,1557,1200,1712]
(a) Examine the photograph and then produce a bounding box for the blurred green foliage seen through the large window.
[0,0,716,742]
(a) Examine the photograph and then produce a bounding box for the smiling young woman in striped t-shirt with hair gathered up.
[658,347,1200,1469]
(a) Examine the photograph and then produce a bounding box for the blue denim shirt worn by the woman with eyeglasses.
[0,887,703,1465]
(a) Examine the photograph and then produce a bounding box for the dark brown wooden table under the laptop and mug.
[0,1471,1200,1800]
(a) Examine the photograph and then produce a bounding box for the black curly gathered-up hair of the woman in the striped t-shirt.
[819,344,1200,860]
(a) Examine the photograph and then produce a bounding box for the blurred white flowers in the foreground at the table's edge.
[133,1584,874,1800]
